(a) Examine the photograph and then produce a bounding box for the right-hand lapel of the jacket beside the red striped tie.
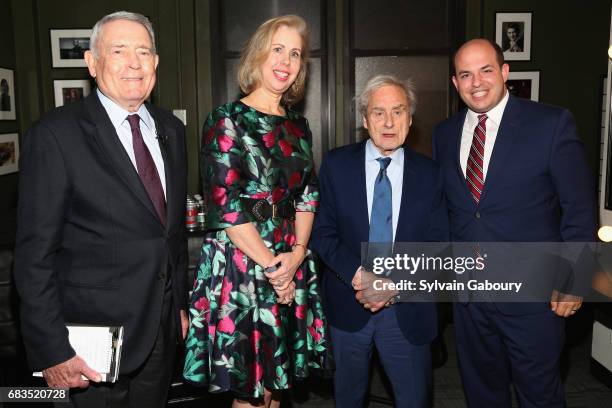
[480,96,520,205]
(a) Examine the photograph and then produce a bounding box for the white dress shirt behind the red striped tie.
[459,91,509,181]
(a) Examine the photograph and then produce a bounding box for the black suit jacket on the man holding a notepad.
[14,92,187,373]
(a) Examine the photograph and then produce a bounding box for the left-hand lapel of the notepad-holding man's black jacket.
[85,92,161,225]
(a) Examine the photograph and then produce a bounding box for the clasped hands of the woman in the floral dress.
[264,245,306,305]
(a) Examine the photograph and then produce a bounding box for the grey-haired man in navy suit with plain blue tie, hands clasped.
[311,75,448,408]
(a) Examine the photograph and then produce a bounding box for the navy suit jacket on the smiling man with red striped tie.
[433,96,597,314]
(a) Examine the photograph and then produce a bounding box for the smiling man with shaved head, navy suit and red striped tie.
[434,39,596,408]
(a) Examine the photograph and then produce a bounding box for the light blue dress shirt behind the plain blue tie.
[365,139,404,241]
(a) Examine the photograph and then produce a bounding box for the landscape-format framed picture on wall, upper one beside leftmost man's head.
[50,29,92,68]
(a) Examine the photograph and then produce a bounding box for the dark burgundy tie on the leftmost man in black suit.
[127,115,166,225]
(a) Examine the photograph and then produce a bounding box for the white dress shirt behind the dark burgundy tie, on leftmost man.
[96,89,166,197]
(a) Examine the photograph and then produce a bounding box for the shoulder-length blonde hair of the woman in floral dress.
[238,14,309,105]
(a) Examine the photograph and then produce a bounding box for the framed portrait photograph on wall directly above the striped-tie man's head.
[495,13,531,61]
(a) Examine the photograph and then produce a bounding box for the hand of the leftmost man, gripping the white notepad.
[42,356,102,388]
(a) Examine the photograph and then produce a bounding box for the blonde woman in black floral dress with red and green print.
[184,15,330,407]
